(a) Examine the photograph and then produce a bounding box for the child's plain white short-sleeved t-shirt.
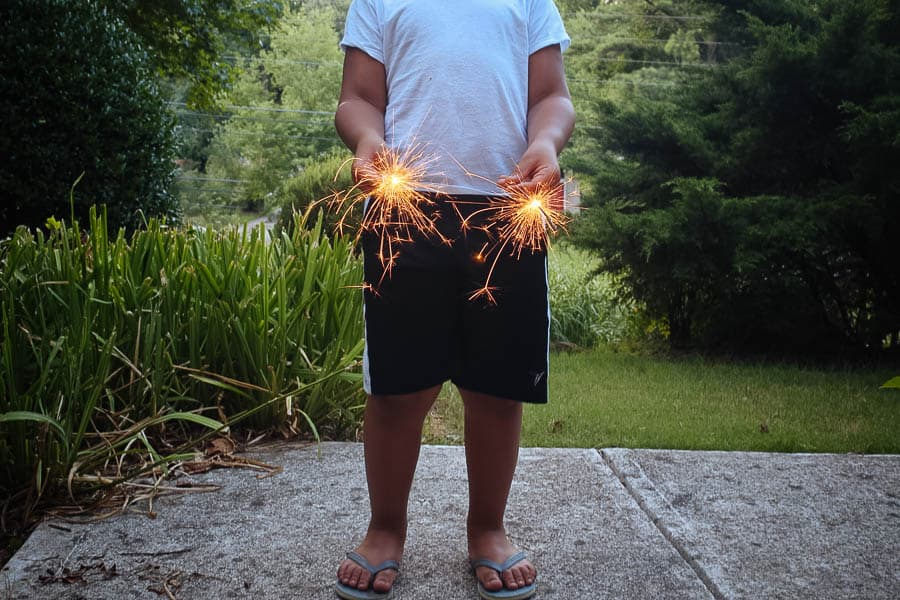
[341,0,569,194]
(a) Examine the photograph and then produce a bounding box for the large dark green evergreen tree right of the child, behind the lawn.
[573,0,900,352]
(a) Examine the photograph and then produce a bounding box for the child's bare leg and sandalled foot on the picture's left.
[338,386,441,592]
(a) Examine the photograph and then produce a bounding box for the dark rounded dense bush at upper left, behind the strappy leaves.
[0,0,176,235]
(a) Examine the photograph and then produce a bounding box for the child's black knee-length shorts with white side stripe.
[362,196,550,403]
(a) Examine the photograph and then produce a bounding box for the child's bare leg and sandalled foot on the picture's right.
[460,390,537,591]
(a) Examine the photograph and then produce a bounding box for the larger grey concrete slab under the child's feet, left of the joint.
[0,443,712,600]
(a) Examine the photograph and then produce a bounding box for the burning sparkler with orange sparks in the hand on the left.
[331,144,450,283]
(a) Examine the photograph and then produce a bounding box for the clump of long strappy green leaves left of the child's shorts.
[0,209,363,504]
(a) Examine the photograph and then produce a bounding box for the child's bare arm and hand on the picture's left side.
[334,48,387,179]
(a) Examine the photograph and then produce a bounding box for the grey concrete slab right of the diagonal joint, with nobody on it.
[602,449,900,599]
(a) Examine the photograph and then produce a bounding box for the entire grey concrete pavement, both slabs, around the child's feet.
[0,443,900,600]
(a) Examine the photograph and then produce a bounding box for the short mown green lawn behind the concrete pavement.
[425,348,900,453]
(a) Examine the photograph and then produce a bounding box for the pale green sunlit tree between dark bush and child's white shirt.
[182,6,343,216]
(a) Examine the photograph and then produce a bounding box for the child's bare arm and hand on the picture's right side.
[499,45,575,199]
